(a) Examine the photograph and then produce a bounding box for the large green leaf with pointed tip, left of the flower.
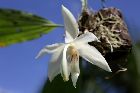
[0,9,59,47]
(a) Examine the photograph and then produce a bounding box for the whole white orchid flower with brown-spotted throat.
[37,5,111,87]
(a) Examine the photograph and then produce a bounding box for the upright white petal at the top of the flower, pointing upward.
[62,5,79,43]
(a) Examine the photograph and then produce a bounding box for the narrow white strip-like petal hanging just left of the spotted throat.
[60,44,70,81]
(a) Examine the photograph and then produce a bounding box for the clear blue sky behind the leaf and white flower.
[0,0,140,93]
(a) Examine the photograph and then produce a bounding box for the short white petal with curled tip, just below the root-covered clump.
[74,32,99,43]
